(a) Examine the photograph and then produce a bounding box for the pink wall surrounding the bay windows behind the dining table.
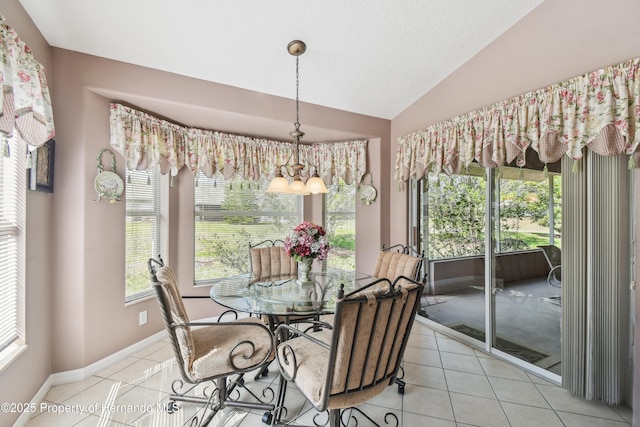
[46,49,390,372]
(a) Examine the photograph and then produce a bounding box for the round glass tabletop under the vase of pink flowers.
[210,269,376,316]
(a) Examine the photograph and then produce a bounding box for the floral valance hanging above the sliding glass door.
[395,58,640,182]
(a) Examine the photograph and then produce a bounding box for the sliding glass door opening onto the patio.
[412,160,562,374]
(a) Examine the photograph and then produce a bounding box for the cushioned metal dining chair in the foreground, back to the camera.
[273,275,424,427]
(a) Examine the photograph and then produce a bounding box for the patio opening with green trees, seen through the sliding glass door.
[420,167,561,259]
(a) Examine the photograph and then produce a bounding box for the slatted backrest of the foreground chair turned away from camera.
[323,276,424,409]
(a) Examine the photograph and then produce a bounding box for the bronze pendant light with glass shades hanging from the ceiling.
[266,40,329,196]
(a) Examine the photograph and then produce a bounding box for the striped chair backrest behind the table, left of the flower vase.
[249,240,298,280]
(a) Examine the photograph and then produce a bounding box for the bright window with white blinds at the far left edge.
[0,137,27,354]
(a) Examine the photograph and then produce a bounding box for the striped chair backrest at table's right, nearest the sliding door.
[373,245,424,282]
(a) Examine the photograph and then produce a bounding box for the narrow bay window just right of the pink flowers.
[325,178,356,270]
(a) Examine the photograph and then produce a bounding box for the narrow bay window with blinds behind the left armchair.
[124,167,168,302]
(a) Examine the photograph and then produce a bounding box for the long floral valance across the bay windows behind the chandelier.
[111,103,367,184]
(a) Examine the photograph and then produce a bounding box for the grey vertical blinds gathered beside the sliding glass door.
[562,153,631,404]
